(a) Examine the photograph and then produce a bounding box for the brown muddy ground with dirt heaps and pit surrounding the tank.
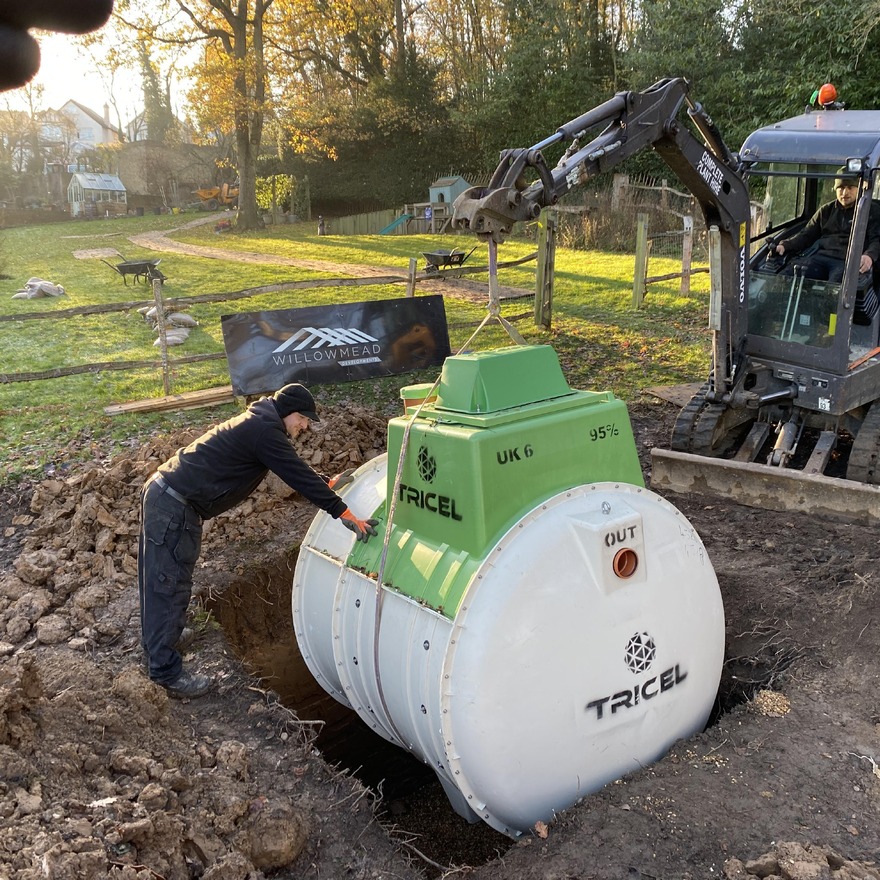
[0,400,880,880]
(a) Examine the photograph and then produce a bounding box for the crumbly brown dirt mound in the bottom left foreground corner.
[0,652,308,880]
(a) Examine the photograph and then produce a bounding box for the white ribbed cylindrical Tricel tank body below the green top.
[293,457,724,837]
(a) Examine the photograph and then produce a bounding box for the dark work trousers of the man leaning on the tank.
[138,479,202,685]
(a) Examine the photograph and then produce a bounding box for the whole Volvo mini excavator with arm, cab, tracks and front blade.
[452,78,880,522]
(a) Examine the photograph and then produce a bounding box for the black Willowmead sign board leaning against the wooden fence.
[220,296,449,396]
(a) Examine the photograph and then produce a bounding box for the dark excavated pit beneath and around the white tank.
[209,549,784,870]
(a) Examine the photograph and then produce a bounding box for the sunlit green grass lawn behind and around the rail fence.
[0,215,709,483]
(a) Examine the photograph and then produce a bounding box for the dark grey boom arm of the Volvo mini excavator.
[452,78,750,397]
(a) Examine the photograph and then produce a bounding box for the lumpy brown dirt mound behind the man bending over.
[0,408,386,650]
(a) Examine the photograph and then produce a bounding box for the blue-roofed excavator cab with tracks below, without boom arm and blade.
[661,109,880,507]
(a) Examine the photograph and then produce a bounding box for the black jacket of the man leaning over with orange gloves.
[159,397,347,519]
